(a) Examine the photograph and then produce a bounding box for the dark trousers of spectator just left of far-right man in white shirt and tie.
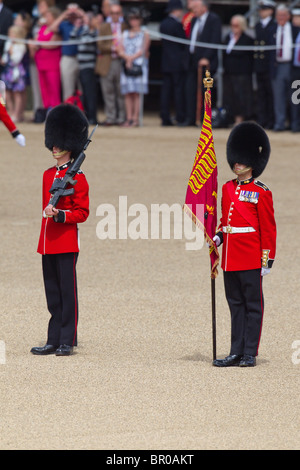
[256,73,274,129]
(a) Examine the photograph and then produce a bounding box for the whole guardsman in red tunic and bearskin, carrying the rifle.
[31,104,89,356]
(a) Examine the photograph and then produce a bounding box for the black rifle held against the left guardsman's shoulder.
[49,124,98,207]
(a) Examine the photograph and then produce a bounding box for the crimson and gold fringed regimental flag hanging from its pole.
[184,90,219,279]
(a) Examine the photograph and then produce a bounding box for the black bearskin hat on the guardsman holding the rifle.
[45,104,89,159]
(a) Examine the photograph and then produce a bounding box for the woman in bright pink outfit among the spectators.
[34,7,61,109]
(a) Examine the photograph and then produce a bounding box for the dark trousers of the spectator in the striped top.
[79,68,98,124]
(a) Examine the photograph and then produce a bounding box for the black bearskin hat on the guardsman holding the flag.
[227,121,271,178]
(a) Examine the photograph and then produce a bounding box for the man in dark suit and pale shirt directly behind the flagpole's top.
[187,0,222,126]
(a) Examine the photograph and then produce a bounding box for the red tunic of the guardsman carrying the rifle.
[37,164,89,255]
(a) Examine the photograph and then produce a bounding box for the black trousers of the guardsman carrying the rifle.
[42,253,78,346]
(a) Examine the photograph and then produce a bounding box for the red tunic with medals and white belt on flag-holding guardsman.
[218,178,276,271]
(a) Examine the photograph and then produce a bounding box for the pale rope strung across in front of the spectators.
[0,28,299,52]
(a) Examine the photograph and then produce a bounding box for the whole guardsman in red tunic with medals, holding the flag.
[213,122,276,367]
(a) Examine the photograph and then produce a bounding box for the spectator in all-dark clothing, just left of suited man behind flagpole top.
[160,0,188,126]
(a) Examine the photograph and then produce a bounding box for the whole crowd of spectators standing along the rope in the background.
[0,0,300,132]
